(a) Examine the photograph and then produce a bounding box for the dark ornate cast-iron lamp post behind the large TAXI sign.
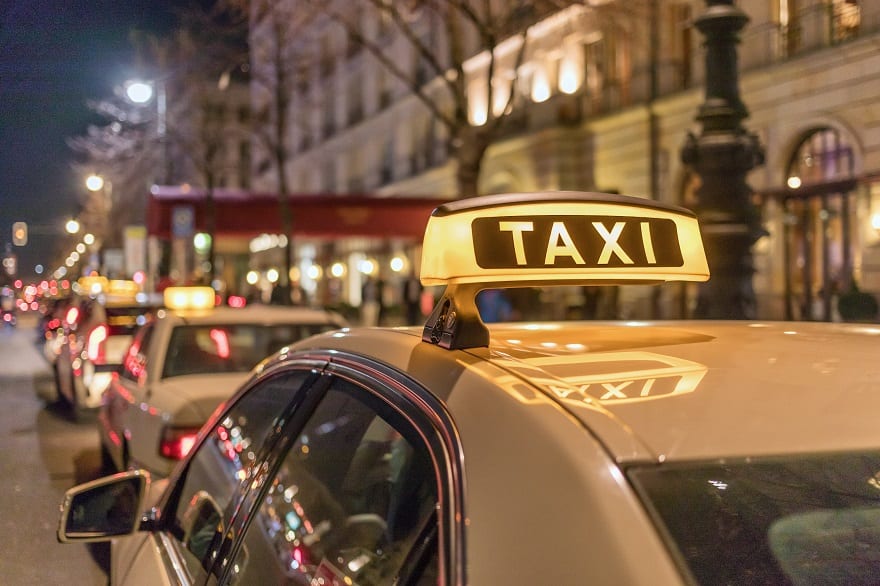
[681,0,766,319]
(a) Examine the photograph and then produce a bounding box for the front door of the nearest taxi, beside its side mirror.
[114,366,318,584]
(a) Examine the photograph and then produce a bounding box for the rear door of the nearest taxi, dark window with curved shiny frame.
[218,355,464,586]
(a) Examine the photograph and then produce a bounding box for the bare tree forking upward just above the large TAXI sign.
[308,0,574,197]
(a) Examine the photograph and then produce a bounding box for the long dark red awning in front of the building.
[147,187,449,240]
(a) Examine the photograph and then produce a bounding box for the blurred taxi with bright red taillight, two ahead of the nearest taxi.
[49,277,161,420]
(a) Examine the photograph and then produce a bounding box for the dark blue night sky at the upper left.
[0,0,180,276]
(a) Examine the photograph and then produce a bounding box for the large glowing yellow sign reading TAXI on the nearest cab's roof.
[421,192,709,287]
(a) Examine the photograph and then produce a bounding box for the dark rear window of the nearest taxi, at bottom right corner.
[628,452,880,585]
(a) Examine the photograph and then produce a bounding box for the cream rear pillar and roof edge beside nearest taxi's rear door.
[282,328,680,584]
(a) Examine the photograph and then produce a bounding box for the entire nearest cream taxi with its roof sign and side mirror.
[58,192,880,586]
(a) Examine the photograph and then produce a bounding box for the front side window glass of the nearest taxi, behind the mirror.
[170,371,309,581]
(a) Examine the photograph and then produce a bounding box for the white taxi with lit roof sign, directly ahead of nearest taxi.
[98,287,345,475]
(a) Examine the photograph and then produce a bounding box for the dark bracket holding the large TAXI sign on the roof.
[422,284,489,350]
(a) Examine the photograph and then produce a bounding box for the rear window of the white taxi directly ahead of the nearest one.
[162,324,337,378]
